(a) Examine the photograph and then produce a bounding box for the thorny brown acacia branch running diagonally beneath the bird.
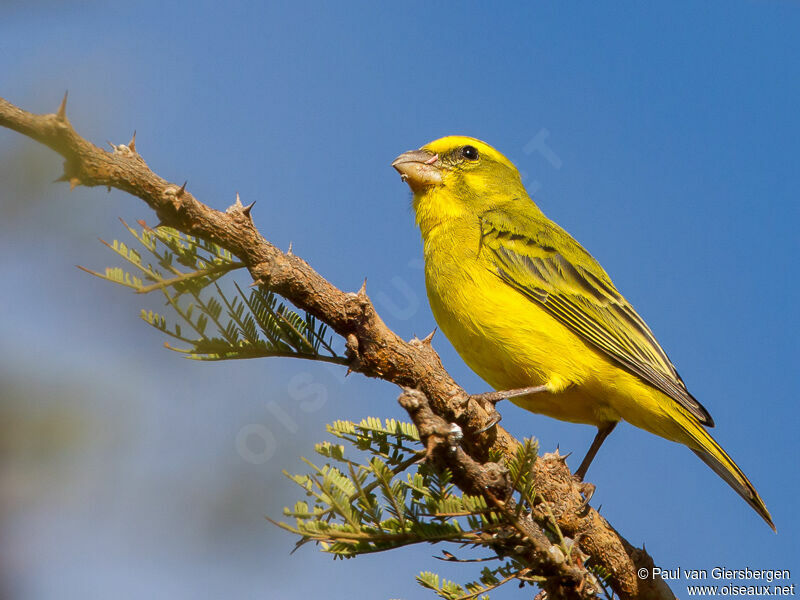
[0,96,674,599]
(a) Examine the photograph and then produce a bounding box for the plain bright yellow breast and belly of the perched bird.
[425,226,615,424]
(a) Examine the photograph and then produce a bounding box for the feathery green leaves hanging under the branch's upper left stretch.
[81,221,347,364]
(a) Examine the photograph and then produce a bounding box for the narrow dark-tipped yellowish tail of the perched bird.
[679,413,778,533]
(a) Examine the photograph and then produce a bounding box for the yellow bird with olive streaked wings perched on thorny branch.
[392,136,775,529]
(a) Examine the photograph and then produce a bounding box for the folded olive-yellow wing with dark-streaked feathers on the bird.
[480,206,714,427]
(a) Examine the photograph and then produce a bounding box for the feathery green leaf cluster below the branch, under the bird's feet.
[273,417,608,600]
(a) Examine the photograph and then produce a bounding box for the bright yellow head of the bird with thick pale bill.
[392,135,528,235]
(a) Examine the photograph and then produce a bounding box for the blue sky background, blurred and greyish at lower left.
[0,0,800,598]
